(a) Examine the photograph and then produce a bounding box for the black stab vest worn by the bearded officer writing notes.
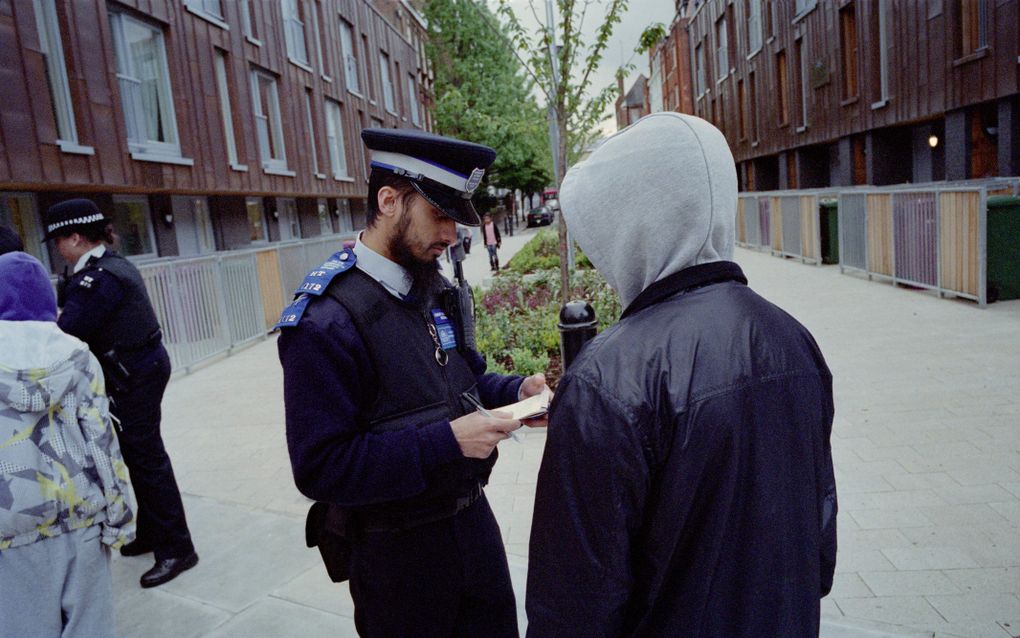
[326,267,497,520]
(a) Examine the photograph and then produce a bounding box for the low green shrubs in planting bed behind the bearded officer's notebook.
[473,233,621,381]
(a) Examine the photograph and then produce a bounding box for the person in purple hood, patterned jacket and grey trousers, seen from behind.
[0,252,135,638]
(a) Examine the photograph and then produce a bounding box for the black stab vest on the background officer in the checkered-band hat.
[68,250,159,355]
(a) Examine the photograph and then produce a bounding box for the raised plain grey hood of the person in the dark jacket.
[560,112,736,307]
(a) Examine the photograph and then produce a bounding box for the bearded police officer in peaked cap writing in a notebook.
[278,129,546,637]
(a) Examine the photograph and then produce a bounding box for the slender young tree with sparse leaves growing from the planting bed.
[499,0,627,303]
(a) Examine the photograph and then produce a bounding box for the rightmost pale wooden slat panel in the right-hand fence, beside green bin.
[938,192,981,296]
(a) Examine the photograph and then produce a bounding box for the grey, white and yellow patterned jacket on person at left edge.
[0,321,135,551]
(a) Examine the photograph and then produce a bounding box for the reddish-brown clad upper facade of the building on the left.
[0,0,429,198]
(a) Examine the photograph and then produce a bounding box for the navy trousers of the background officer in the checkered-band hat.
[110,345,195,560]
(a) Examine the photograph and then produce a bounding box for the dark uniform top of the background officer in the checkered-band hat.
[57,250,162,393]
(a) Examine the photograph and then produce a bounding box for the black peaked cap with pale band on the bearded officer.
[361,129,496,226]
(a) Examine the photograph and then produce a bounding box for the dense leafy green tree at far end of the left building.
[424,0,552,200]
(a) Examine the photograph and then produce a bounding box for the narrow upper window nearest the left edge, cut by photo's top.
[35,0,95,155]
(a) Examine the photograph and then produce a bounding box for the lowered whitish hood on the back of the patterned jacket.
[0,321,91,412]
